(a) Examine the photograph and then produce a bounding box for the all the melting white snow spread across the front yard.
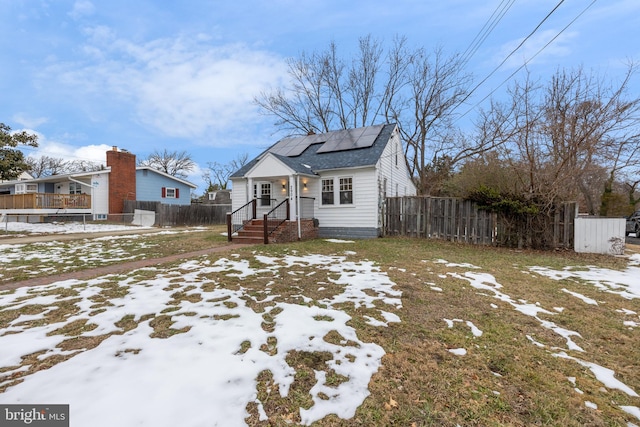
[0,222,640,427]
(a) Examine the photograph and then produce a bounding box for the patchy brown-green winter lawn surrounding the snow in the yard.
[0,229,640,426]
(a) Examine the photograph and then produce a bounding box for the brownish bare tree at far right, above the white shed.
[479,66,640,213]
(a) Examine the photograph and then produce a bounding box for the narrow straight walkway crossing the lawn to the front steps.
[0,242,248,291]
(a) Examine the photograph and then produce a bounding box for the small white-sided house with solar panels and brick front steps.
[228,124,416,243]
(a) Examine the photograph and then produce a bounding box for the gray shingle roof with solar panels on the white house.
[231,124,396,178]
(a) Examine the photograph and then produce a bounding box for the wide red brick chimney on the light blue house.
[107,146,136,214]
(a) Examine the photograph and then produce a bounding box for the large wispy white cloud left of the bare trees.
[47,27,286,146]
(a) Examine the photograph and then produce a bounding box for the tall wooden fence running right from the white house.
[383,196,577,248]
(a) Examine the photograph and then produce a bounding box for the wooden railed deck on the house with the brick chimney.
[0,193,91,213]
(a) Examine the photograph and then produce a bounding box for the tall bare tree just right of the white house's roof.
[385,39,476,194]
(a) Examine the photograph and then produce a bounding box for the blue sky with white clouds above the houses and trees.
[0,0,640,192]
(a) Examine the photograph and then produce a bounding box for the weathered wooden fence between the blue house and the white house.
[124,200,231,227]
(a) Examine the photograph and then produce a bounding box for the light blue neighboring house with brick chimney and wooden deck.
[0,147,196,220]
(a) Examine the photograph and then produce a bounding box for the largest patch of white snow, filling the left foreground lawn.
[0,255,402,427]
